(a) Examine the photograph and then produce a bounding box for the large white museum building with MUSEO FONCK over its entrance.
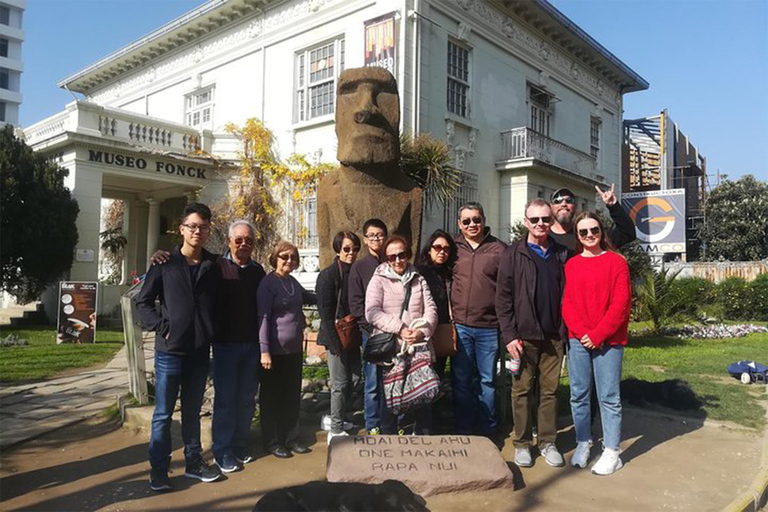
[25,0,648,314]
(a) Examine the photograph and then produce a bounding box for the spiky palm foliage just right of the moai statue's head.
[400,133,461,210]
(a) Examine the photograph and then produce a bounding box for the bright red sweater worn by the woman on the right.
[563,251,632,347]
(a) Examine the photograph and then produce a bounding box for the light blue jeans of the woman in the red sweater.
[568,338,624,450]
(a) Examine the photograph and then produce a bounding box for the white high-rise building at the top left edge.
[0,0,26,126]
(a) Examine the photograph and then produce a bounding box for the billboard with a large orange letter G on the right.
[621,188,686,254]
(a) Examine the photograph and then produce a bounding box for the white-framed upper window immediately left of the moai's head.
[295,37,344,122]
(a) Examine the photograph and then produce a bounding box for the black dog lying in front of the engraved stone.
[253,480,429,512]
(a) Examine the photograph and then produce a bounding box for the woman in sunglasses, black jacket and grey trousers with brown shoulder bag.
[316,231,360,444]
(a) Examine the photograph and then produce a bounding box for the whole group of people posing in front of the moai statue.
[136,187,634,491]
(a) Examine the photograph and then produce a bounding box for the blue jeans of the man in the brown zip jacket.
[451,324,499,434]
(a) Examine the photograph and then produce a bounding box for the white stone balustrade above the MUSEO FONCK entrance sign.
[24,101,210,153]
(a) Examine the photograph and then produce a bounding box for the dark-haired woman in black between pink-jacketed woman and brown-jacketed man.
[416,229,457,383]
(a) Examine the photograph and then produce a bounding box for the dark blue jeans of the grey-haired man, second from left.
[212,343,261,460]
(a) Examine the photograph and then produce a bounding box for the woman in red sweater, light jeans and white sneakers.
[563,212,632,475]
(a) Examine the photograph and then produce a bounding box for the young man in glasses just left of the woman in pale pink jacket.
[349,219,387,435]
